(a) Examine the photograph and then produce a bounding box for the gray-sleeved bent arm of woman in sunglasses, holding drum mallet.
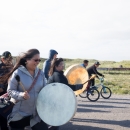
[7,72,25,101]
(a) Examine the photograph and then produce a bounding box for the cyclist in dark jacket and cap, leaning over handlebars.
[87,61,104,86]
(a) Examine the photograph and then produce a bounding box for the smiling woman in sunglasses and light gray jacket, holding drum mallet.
[0,49,48,130]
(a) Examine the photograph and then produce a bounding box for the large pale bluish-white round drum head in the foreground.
[37,83,77,126]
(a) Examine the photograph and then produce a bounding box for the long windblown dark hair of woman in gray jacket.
[0,49,40,84]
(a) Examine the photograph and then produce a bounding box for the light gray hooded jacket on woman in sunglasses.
[7,66,45,126]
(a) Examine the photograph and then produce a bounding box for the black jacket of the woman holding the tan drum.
[47,71,76,91]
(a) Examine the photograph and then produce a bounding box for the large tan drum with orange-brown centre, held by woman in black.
[64,64,89,95]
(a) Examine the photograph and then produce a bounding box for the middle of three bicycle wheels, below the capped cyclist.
[87,88,100,102]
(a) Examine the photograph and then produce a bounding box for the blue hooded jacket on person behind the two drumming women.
[43,50,58,79]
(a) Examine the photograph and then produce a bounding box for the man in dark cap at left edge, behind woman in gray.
[0,51,13,130]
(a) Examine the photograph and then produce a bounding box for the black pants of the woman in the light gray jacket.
[10,117,48,130]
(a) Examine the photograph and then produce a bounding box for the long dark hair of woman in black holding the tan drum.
[49,58,64,76]
